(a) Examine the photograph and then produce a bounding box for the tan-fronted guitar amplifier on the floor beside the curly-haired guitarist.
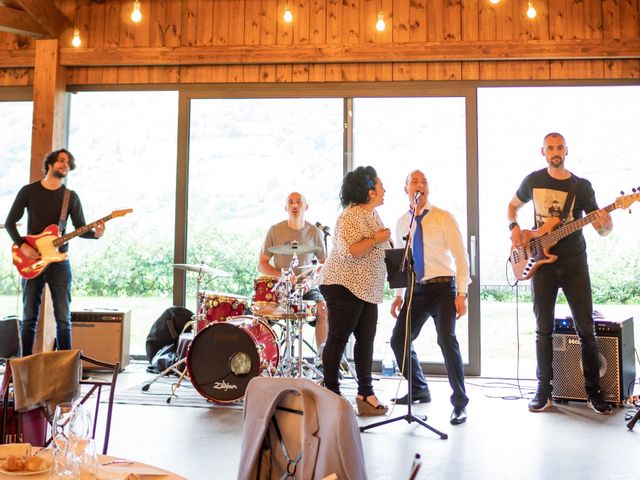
[71,309,131,370]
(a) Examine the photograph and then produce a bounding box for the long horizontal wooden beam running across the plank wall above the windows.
[0,38,640,68]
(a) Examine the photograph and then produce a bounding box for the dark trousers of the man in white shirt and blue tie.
[390,283,469,407]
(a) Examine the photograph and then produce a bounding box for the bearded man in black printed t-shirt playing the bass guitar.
[508,133,613,415]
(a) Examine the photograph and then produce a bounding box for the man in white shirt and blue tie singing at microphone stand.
[391,170,471,425]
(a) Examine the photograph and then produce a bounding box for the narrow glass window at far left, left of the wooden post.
[0,101,33,316]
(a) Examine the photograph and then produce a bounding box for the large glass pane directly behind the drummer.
[186,99,343,316]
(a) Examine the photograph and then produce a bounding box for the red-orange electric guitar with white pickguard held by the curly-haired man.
[11,208,133,280]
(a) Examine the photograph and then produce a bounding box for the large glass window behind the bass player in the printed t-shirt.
[478,86,640,378]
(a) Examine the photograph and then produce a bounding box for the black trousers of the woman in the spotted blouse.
[320,285,378,396]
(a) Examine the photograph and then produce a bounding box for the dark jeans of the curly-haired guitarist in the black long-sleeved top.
[21,260,71,356]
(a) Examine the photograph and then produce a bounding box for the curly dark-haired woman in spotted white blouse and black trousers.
[320,167,390,415]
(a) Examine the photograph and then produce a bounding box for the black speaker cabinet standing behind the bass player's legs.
[553,318,635,405]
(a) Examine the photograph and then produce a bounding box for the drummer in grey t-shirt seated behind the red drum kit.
[258,192,327,359]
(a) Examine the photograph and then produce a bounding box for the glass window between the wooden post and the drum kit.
[68,92,178,354]
